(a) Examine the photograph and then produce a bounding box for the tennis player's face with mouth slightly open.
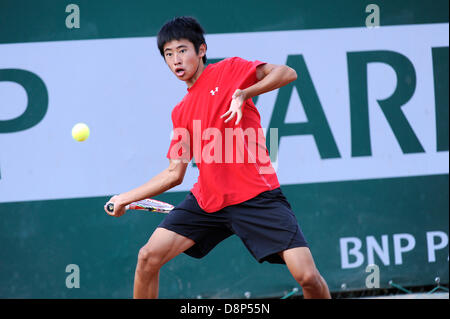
[164,39,205,85]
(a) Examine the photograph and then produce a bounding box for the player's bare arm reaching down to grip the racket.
[105,159,188,217]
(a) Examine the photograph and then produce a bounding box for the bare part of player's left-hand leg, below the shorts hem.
[133,227,195,298]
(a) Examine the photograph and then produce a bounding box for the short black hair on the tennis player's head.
[157,16,206,64]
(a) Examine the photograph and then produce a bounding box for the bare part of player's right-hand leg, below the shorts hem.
[279,247,331,298]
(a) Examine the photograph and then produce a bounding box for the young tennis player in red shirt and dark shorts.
[105,17,330,298]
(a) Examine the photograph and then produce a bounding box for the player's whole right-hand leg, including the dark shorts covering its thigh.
[229,188,330,298]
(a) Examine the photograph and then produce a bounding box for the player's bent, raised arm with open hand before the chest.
[221,63,297,125]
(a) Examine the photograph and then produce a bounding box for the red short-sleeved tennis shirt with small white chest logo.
[167,57,280,213]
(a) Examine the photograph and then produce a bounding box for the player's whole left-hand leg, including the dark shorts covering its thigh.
[134,192,232,298]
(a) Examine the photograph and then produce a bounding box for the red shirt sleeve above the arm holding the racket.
[166,109,192,163]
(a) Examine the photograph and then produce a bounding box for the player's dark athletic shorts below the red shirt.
[158,188,308,264]
